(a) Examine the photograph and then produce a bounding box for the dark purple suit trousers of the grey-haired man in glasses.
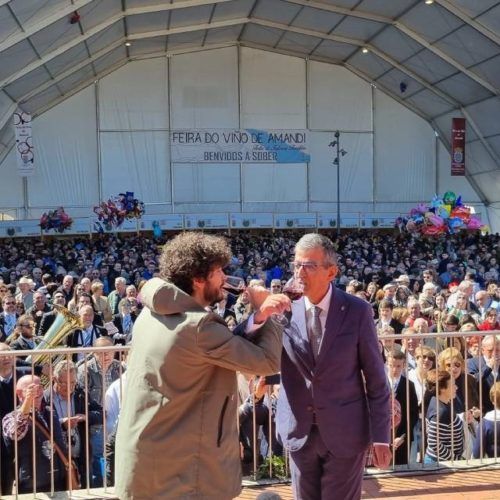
[290,425,366,500]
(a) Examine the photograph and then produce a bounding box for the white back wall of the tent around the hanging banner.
[0,46,479,223]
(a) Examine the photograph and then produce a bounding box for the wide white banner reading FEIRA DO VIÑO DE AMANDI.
[170,129,311,163]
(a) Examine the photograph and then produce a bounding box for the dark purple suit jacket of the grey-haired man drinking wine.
[277,287,390,457]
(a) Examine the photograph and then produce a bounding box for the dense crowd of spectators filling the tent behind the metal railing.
[0,231,500,493]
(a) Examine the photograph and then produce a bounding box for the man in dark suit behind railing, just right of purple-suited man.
[387,349,418,465]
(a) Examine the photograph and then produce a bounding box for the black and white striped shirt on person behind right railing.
[425,398,464,460]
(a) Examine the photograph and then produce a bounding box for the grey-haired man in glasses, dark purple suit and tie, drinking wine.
[277,233,391,500]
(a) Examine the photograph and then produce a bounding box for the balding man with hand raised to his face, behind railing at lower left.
[2,375,67,493]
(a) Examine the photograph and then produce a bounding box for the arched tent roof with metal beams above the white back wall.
[0,0,500,204]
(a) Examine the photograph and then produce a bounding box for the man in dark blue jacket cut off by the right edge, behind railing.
[467,335,500,413]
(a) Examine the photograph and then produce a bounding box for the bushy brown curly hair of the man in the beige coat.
[160,232,231,295]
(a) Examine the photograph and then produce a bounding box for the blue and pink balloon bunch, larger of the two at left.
[94,191,144,232]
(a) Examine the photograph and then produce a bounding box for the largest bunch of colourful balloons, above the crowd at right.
[396,191,487,236]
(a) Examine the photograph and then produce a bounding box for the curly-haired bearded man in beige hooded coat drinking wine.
[115,232,290,500]
